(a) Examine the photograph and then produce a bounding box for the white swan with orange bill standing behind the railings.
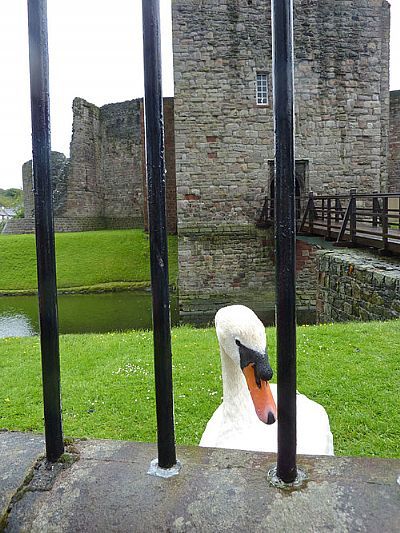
[200,305,334,455]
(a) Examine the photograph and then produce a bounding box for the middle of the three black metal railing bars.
[142,0,176,468]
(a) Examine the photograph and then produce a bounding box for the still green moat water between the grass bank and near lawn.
[0,290,178,337]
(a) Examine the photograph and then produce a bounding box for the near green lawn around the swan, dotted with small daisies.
[0,321,400,457]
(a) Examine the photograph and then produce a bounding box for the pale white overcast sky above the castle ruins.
[0,0,400,188]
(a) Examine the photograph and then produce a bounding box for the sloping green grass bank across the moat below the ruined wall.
[0,230,177,293]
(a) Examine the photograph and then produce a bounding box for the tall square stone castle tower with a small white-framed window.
[173,0,390,315]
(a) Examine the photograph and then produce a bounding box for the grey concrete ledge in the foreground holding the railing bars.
[0,433,400,533]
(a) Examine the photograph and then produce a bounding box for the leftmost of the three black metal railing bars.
[28,0,64,462]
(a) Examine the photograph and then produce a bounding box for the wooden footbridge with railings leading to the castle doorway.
[257,189,400,254]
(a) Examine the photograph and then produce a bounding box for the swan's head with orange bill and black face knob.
[215,305,277,424]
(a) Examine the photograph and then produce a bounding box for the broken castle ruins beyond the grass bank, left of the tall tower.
[5,98,176,233]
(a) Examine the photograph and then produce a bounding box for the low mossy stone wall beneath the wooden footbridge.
[317,250,400,322]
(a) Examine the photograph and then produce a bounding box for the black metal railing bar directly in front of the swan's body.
[272,0,297,483]
